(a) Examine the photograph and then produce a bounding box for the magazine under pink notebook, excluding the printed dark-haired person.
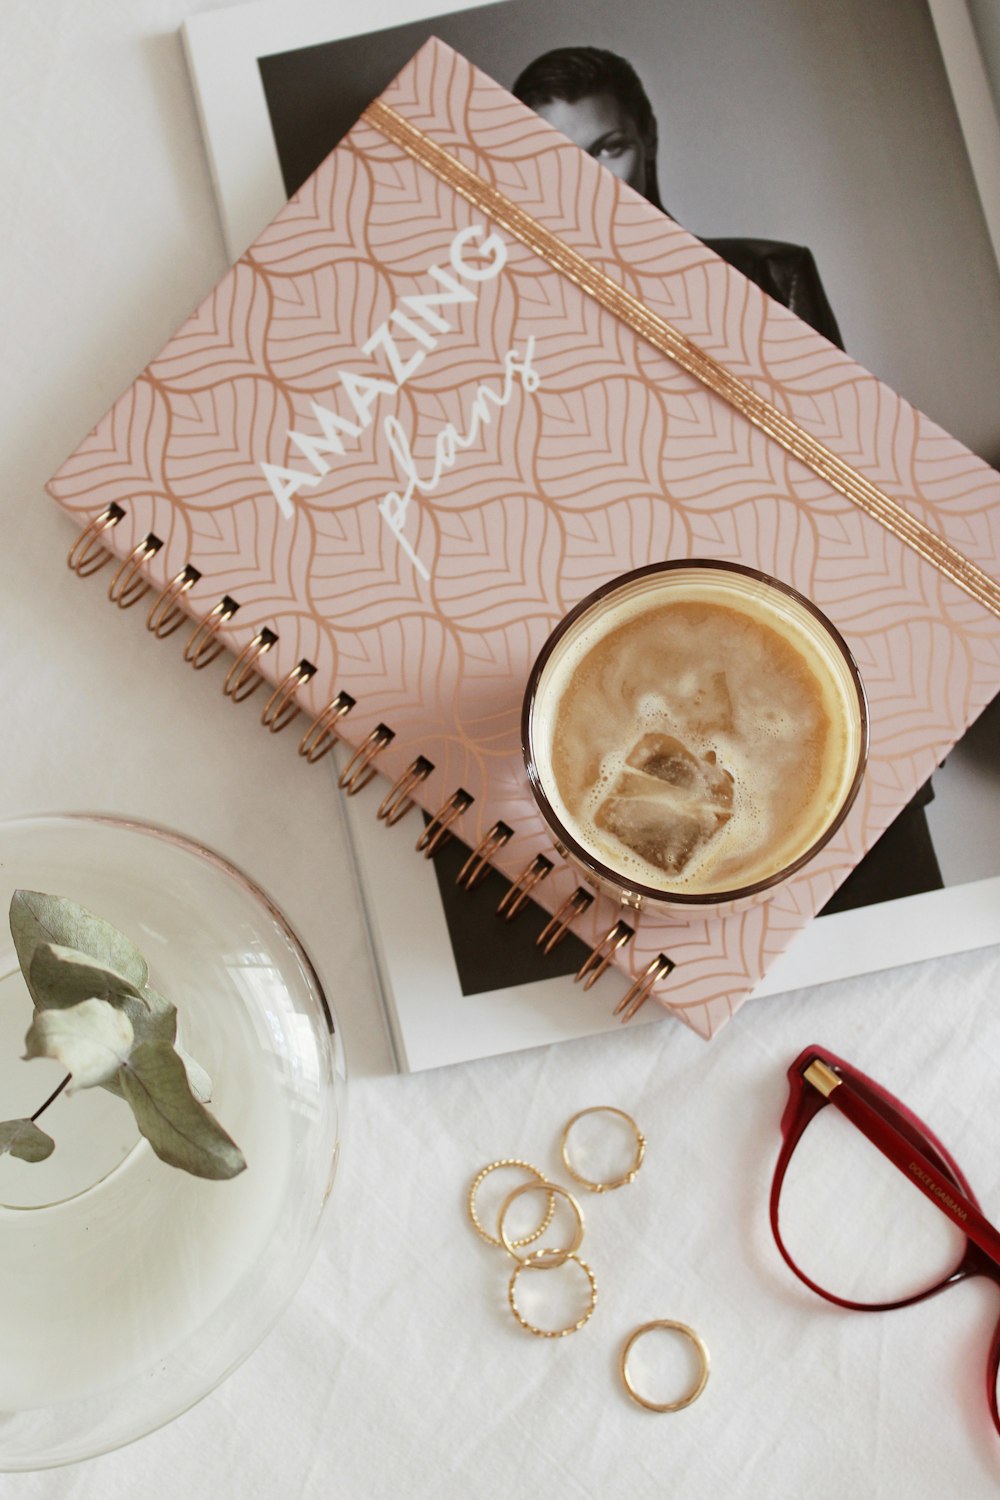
[184,0,1000,1071]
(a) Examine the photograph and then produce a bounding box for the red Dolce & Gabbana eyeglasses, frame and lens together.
[771,1047,1000,1433]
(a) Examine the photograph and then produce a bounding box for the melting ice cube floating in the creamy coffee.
[595,734,733,875]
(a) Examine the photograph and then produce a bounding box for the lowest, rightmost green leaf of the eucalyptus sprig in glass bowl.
[118,1041,246,1179]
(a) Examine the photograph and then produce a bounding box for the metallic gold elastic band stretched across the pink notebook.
[361,99,1000,615]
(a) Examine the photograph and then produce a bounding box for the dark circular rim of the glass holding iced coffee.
[520,558,870,911]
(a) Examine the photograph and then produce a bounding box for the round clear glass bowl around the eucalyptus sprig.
[0,815,346,1470]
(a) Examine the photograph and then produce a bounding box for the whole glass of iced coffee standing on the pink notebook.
[525,561,867,905]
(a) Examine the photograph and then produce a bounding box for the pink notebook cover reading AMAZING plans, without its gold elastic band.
[49,41,1000,1037]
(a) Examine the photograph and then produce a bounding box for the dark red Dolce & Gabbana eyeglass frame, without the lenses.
[769,1046,1000,1434]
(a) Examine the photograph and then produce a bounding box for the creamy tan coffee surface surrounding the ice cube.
[532,575,859,894]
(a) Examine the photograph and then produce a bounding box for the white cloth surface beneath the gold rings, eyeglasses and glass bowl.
[0,0,1000,1500]
